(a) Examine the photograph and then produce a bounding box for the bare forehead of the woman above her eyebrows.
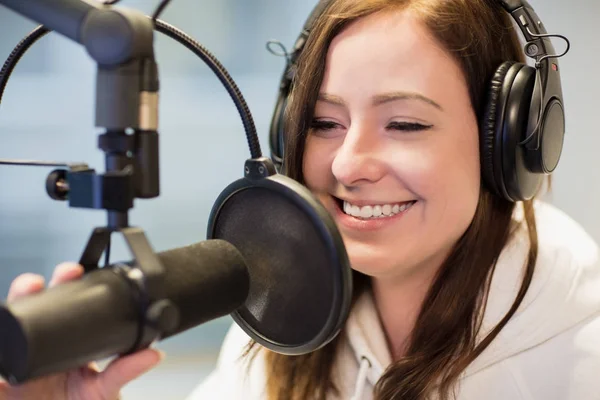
[323,10,463,96]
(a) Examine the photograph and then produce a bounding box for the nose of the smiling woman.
[331,126,385,187]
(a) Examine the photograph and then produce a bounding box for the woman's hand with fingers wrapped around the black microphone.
[0,263,163,400]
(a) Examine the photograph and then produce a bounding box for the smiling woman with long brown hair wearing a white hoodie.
[4,0,600,400]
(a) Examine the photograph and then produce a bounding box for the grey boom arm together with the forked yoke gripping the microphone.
[0,0,173,352]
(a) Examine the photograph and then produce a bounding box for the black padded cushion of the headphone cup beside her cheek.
[480,61,515,198]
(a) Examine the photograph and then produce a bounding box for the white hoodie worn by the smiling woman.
[188,202,600,400]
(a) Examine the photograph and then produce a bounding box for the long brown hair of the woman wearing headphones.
[252,0,537,400]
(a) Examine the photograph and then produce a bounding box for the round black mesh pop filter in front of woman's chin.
[207,157,352,355]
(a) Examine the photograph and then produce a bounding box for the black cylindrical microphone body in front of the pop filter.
[0,239,250,383]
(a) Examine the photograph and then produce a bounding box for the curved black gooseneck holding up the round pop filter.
[0,9,262,158]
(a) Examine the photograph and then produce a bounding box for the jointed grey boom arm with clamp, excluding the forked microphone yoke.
[0,0,160,209]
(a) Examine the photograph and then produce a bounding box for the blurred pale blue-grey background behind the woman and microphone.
[0,0,600,400]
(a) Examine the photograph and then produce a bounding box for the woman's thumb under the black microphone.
[98,348,165,399]
